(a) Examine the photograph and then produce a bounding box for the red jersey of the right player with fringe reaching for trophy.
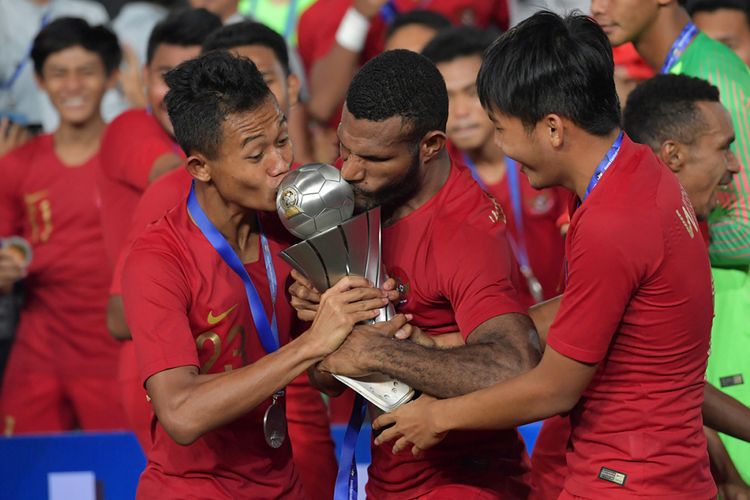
[547,137,716,499]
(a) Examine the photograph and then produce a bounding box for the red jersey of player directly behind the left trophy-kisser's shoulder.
[98,109,184,267]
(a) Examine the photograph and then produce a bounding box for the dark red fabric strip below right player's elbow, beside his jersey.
[529,415,570,500]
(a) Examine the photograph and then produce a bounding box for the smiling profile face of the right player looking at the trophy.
[490,110,560,189]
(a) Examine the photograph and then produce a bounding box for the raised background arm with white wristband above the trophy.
[308,0,387,123]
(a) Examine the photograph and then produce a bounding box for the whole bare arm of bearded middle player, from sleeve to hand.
[320,313,539,398]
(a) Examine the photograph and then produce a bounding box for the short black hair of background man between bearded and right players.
[422,26,497,64]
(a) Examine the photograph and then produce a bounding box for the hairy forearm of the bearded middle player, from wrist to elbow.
[363,339,538,398]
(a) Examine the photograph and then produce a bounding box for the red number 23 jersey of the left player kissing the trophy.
[122,203,304,498]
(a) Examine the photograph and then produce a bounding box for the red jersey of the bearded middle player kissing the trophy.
[367,165,528,499]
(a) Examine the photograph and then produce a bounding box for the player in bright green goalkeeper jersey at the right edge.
[591,0,750,481]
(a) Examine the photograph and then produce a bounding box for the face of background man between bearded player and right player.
[437,56,494,151]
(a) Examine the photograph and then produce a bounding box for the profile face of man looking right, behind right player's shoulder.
[677,102,739,218]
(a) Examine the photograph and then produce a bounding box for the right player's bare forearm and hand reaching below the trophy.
[373,348,596,453]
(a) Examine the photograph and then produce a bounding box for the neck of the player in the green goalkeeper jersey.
[633,7,690,71]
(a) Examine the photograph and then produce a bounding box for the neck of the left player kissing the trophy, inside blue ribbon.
[195,182,258,263]
